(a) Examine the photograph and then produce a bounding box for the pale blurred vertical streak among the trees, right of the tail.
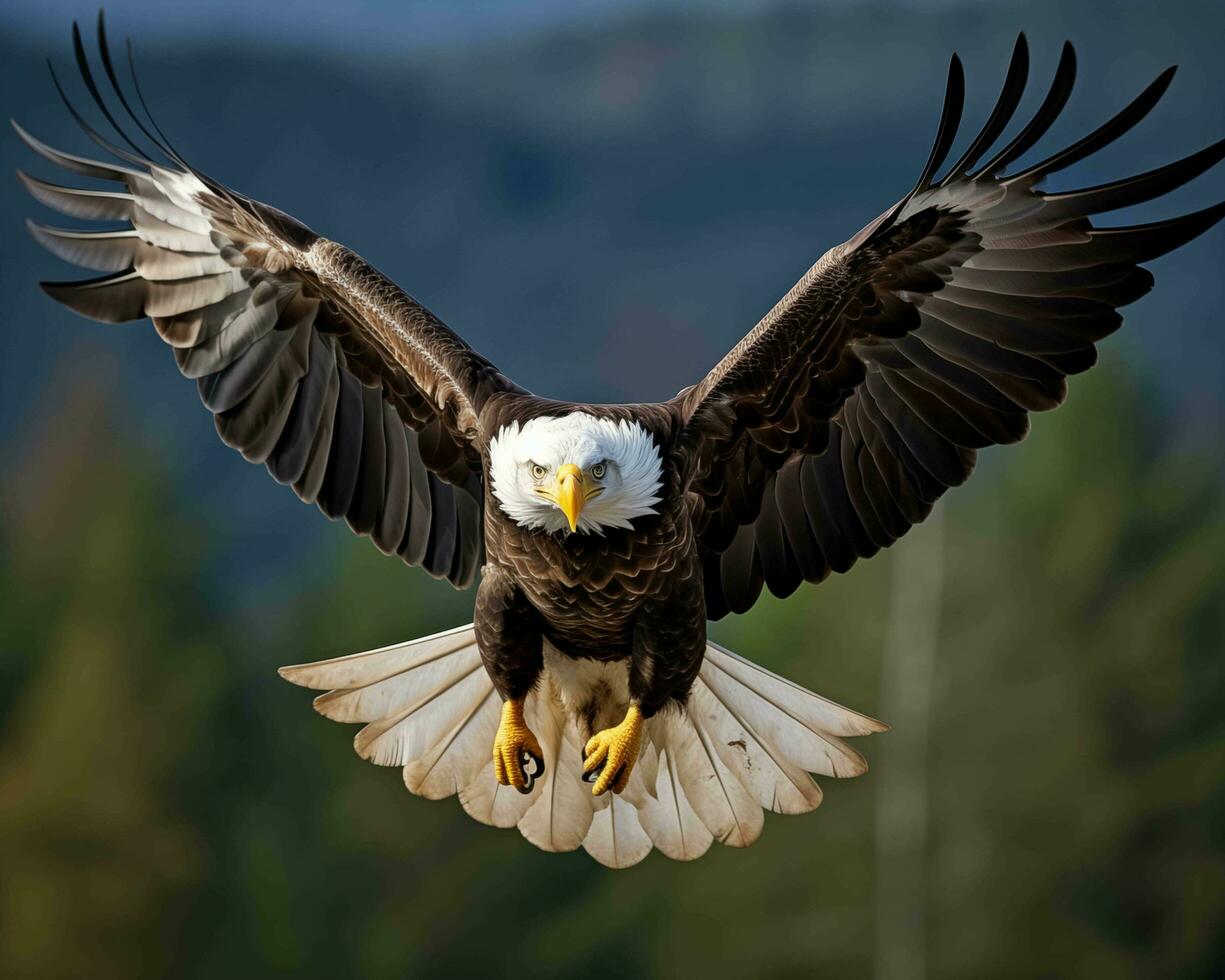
[875,503,944,980]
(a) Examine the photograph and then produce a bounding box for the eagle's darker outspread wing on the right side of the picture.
[674,37,1225,619]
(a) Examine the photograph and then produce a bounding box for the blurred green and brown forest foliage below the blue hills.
[0,370,1225,978]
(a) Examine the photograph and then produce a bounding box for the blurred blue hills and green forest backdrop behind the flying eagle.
[0,0,1225,978]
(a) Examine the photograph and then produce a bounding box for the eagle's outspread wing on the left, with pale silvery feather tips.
[13,16,517,587]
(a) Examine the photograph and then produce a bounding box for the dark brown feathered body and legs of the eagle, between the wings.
[475,394,706,717]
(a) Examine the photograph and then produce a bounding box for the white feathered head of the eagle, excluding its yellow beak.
[489,412,663,534]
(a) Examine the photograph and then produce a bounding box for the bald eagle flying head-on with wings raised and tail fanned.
[15,18,1225,867]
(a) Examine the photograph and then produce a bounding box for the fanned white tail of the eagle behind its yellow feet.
[281,626,887,867]
